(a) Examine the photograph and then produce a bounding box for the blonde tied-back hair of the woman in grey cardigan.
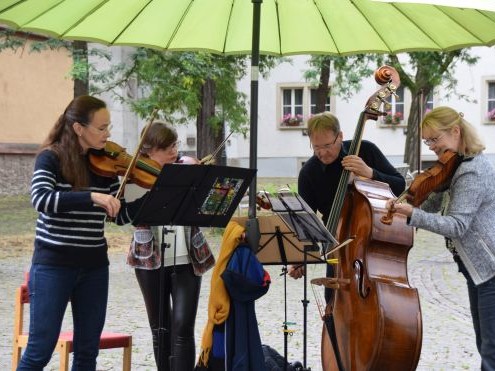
[421,106,485,156]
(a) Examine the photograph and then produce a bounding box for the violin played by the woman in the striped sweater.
[89,141,161,189]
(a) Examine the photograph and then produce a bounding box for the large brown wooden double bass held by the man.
[321,66,422,371]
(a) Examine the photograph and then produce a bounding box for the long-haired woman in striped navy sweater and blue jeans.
[18,96,145,370]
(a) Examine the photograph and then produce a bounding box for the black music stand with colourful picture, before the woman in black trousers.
[132,164,256,371]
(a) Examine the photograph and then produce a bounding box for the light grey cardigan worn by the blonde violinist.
[409,154,495,285]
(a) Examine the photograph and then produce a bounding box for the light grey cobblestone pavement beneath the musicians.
[0,231,480,371]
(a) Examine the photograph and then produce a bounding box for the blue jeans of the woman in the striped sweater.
[17,264,108,371]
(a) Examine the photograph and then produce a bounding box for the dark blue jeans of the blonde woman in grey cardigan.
[456,258,495,371]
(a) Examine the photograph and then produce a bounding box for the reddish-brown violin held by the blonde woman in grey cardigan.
[380,150,462,225]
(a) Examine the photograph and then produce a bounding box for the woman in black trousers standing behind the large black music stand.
[126,121,214,371]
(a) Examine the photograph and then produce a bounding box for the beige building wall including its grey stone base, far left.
[0,41,73,195]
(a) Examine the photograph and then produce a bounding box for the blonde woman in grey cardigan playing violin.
[387,107,495,370]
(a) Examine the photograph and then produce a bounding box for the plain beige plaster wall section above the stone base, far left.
[0,41,74,144]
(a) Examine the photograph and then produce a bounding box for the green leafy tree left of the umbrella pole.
[91,48,276,164]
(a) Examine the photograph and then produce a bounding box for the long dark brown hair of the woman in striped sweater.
[41,95,107,189]
